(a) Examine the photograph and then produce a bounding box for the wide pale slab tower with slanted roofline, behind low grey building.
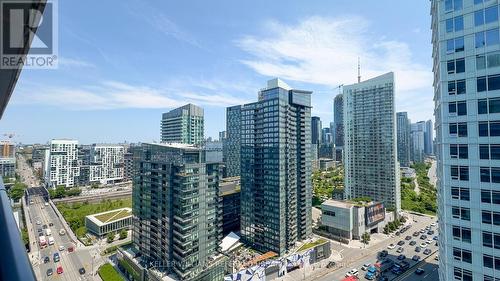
[343,72,401,211]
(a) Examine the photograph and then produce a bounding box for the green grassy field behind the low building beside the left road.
[56,198,132,237]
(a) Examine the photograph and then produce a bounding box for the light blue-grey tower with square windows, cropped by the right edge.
[431,0,500,281]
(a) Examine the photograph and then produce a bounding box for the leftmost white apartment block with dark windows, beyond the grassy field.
[45,139,80,187]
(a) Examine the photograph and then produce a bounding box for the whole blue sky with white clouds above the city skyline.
[0,0,433,143]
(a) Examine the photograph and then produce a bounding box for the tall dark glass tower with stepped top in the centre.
[241,79,312,255]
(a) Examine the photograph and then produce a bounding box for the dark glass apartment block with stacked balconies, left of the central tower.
[132,143,224,280]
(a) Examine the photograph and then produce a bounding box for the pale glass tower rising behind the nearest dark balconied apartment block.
[161,104,204,145]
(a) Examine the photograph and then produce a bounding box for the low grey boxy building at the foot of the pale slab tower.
[321,200,394,240]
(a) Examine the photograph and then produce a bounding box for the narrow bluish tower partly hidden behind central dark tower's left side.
[223,105,241,177]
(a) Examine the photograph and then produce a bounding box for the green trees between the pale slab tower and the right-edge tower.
[401,163,437,215]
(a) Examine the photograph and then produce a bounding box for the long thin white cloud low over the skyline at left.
[9,81,247,110]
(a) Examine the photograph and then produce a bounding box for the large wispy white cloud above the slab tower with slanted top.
[236,16,433,121]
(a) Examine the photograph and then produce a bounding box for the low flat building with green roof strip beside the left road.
[85,208,132,237]
